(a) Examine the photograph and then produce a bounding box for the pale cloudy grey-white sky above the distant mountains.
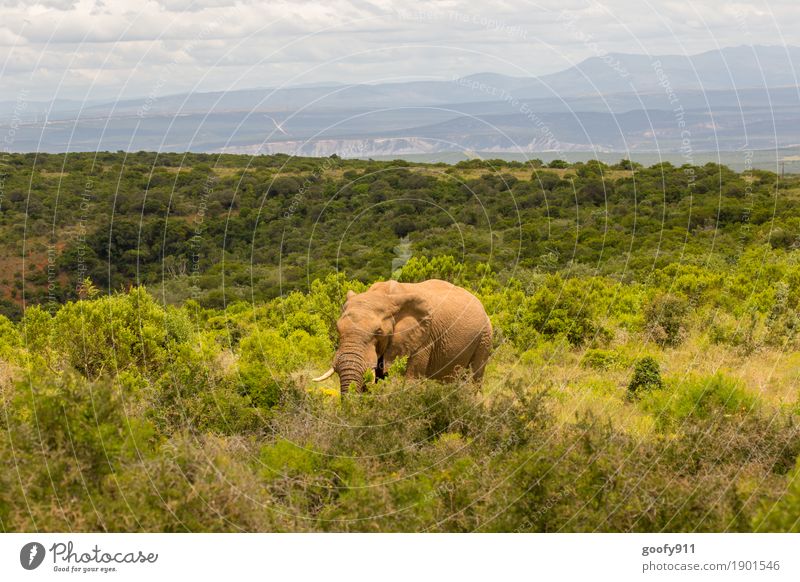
[0,0,800,102]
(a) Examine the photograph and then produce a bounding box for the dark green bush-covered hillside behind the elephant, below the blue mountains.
[0,153,800,317]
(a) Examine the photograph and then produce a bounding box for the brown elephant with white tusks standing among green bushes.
[314,279,492,394]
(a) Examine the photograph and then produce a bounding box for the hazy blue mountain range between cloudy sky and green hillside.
[0,46,800,162]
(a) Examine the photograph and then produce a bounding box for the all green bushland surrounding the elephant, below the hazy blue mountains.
[0,153,800,531]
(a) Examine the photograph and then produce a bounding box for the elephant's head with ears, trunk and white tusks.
[314,281,430,393]
